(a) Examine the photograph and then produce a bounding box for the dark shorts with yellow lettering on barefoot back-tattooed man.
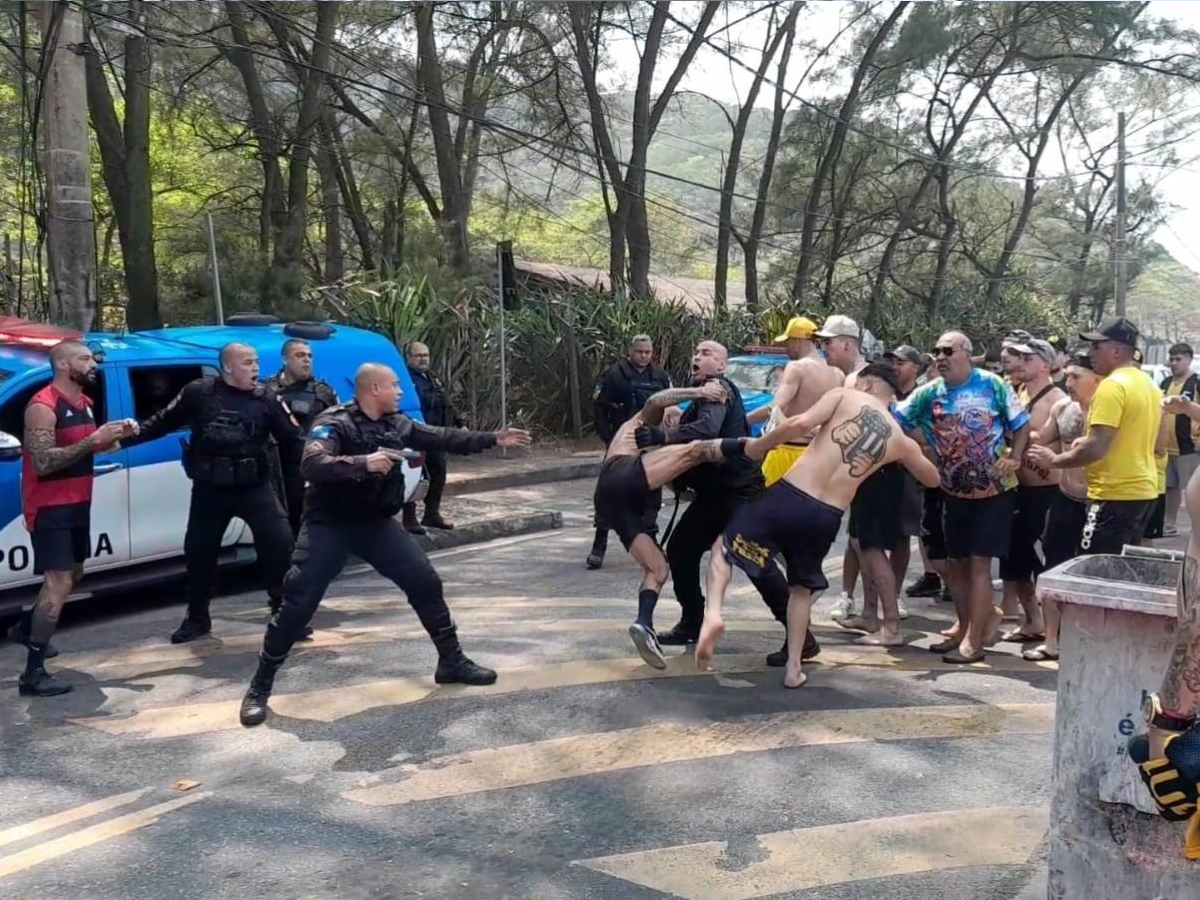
[722,480,841,594]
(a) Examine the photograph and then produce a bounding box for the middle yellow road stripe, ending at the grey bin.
[342,703,1054,806]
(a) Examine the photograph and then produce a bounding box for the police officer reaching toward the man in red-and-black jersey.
[125,343,299,643]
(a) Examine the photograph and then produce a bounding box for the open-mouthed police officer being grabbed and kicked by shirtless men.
[636,341,818,665]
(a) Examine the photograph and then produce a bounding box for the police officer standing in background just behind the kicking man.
[587,335,671,569]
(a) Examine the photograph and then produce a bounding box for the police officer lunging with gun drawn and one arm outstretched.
[240,362,529,726]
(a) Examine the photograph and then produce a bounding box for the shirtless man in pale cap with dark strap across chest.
[1000,338,1067,643]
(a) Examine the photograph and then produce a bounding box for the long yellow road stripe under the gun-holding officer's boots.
[68,648,1054,738]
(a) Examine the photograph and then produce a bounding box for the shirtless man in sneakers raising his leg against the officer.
[595,380,727,668]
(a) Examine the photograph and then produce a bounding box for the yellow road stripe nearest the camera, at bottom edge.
[576,806,1048,900]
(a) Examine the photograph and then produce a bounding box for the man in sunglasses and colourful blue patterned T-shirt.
[895,331,1030,664]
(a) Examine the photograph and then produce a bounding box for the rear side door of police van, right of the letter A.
[122,360,241,563]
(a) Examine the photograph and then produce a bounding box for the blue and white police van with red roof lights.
[0,318,421,616]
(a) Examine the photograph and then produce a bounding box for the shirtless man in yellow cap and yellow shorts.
[751,316,844,487]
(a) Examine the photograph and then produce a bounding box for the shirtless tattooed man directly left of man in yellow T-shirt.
[1021,354,1100,661]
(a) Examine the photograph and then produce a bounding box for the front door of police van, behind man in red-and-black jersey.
[0,364,130,590]
